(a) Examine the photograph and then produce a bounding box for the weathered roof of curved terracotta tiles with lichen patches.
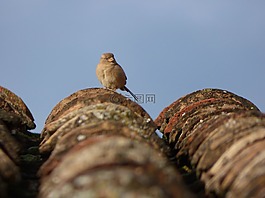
[0,87,265,198]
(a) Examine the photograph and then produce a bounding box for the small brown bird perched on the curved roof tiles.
[96,53,138,101]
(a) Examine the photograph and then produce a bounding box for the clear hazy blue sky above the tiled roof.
[0,0,265,132]
